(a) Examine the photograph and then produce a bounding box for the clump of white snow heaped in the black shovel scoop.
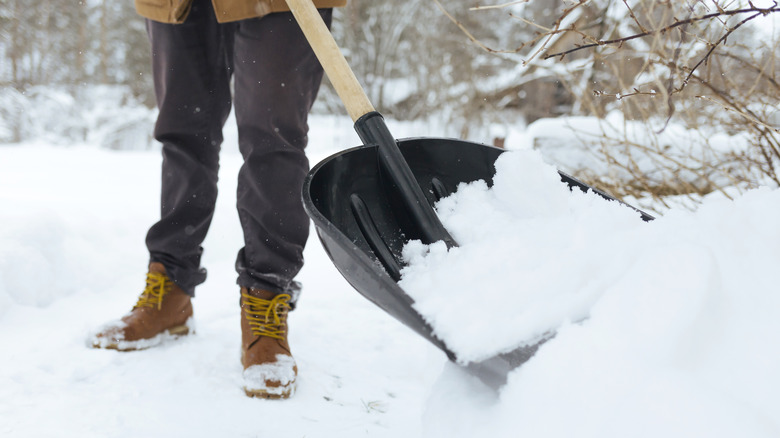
[400,151,646,362]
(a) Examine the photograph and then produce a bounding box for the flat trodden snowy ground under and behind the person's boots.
[0,117,446,437]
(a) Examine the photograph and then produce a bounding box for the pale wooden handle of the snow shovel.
[286,0,375,122]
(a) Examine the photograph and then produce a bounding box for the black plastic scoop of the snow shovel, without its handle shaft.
[303,138,652,388]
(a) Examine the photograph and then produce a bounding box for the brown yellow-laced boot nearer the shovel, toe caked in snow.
[241,287,298,399]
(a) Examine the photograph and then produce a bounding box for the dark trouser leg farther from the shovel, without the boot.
[146,0,235,295]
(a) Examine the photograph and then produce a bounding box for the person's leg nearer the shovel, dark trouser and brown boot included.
[234,10,332,398]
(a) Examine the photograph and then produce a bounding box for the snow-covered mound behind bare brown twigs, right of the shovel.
[507,111,762,212]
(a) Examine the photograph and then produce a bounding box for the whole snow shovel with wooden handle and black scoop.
[286,0,652,389]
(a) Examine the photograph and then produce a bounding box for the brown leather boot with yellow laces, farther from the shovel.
[90,263,194,351]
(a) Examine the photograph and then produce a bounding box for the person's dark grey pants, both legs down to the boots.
[146,0,332,295]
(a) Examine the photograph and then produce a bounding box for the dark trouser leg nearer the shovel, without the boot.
[235,9,332,295]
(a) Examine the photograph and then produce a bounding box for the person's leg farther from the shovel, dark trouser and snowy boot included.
[89,0,235,351]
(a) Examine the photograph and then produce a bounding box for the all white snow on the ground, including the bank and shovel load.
[0,117,780,438]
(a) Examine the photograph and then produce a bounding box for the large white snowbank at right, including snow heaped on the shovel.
[402,152,780,437]
